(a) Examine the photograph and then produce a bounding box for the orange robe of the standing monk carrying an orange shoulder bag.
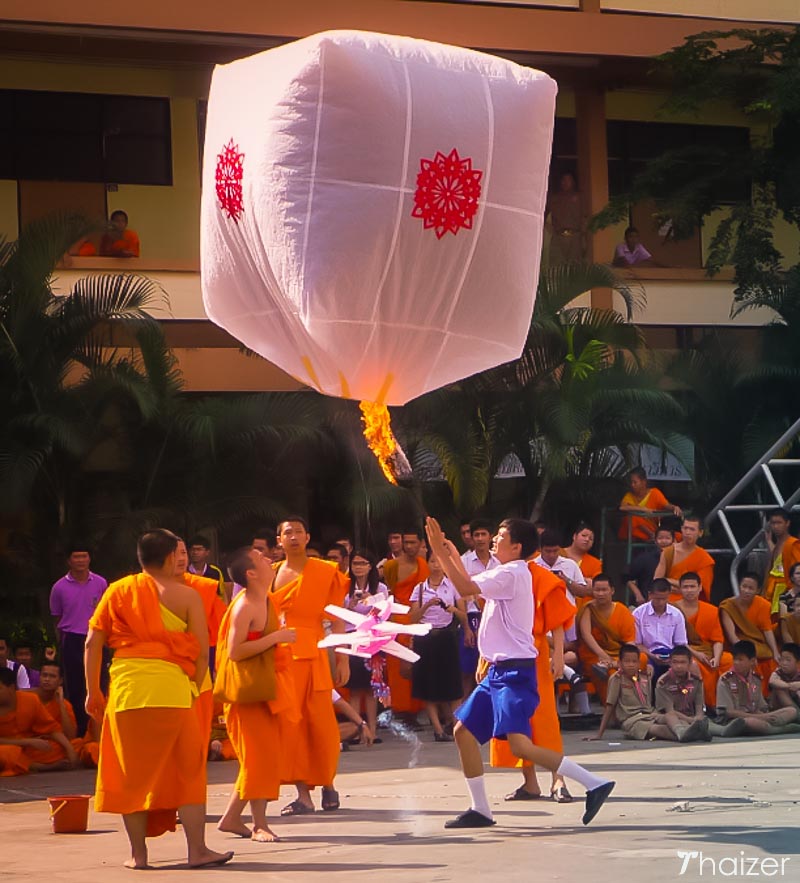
[219,595,300,800]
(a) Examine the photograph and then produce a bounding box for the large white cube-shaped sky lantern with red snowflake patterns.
[202,31,556,480]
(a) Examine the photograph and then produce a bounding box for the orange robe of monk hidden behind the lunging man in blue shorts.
[489,561,575,768]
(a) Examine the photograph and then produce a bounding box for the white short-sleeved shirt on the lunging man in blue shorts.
[472,560,538,662]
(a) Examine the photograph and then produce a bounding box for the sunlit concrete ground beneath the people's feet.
[0,730,800,883]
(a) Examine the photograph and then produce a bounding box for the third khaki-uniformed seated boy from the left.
[717,640,800,736]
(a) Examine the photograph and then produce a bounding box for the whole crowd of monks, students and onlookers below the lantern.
[0,470,800,867]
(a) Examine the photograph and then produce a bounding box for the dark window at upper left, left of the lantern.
[0,90,172,185]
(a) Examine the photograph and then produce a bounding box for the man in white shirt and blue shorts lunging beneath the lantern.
[426,518,614,828]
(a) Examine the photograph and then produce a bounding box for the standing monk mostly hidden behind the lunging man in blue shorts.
[489,561,575,803]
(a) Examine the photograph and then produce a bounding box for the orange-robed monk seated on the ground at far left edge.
[0,668,78,776]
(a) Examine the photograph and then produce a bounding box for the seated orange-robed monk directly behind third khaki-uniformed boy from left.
[719,573,780,696]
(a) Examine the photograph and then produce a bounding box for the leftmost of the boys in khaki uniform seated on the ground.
[584,644,708,742]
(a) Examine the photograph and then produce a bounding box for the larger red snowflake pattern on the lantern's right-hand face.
[411,147,483,239]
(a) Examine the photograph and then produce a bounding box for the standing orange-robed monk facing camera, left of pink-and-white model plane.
[271,515,350,816]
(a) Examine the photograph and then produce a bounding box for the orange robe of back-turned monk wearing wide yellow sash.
[89,573,208,837]
